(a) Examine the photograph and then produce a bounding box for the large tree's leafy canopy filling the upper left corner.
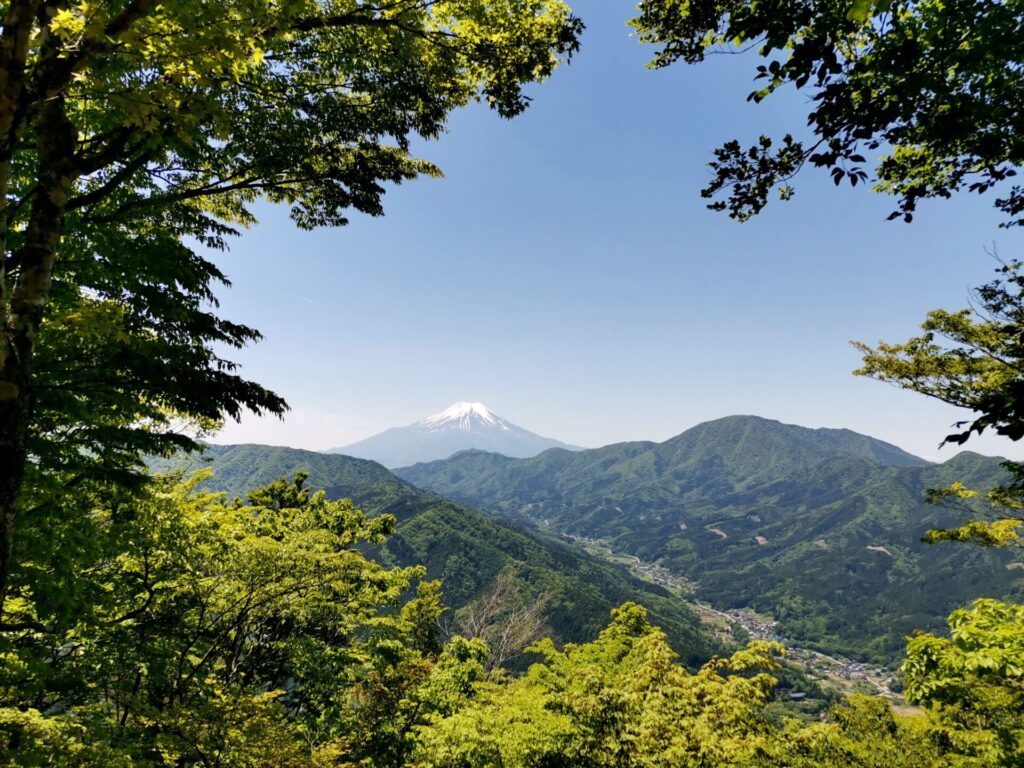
[9,0,580,483]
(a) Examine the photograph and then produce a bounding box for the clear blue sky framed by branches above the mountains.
[207,0,1024,459]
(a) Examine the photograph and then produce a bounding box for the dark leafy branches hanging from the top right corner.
[633,0,1024,226]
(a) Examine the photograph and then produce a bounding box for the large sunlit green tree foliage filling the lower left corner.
[0,475,485,766]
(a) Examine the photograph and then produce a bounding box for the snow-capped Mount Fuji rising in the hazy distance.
[327,402,581,467]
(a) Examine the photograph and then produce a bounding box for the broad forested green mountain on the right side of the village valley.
[397,417,1024,662]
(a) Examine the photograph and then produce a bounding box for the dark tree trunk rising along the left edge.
[0,93,75,621]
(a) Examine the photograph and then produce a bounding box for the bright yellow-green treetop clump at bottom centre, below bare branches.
[417,604,781,767]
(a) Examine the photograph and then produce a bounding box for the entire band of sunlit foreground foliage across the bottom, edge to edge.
[0,475,1024,768]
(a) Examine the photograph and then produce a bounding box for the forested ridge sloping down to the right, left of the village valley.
[151,444,716,664]
